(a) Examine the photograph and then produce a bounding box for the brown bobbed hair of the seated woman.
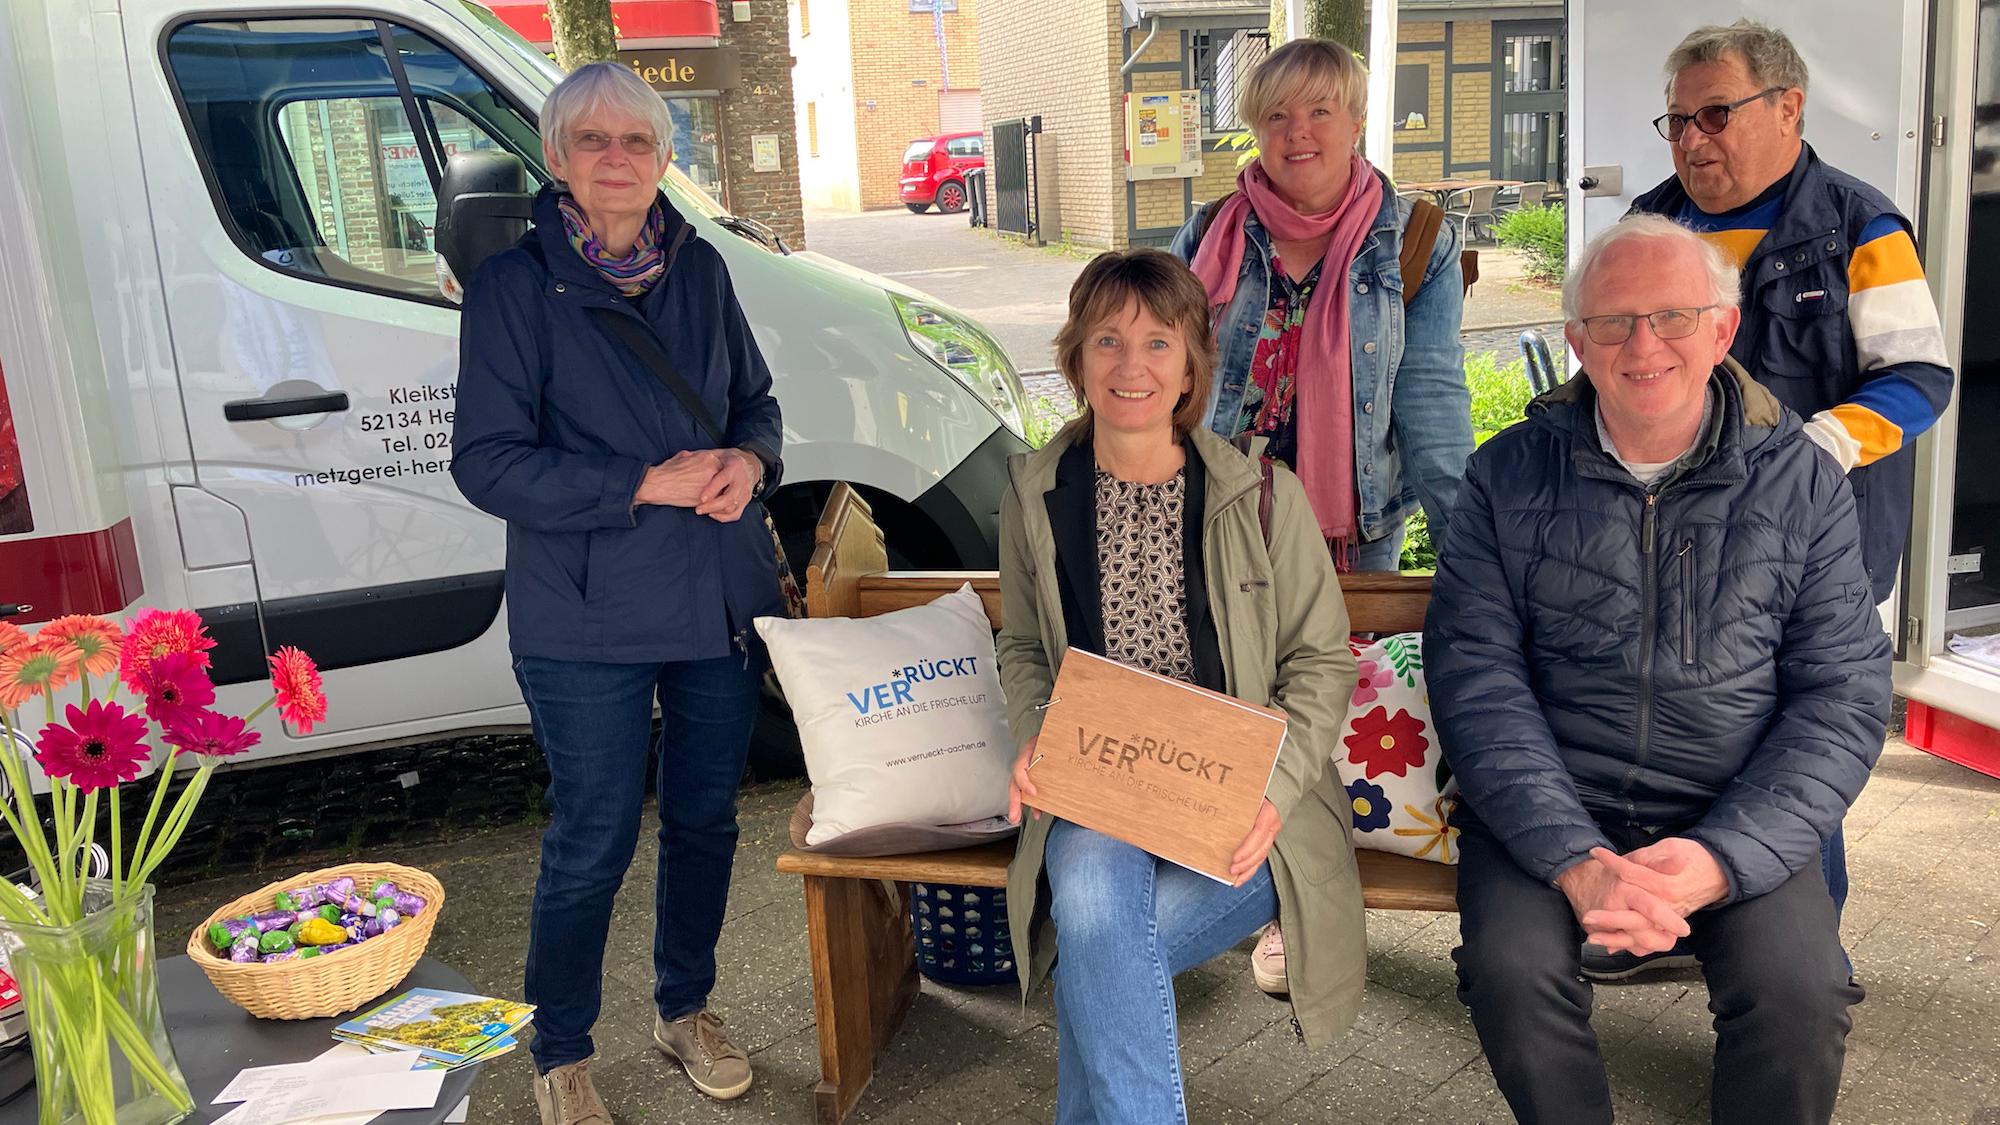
[1056,246,1216,438]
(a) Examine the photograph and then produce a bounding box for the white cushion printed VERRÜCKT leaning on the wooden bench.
[756,583,1014,845]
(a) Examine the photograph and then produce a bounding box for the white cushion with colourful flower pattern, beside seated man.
[1334,633,1458,863]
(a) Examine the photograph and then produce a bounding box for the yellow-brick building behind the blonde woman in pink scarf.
[980,0,1564,246]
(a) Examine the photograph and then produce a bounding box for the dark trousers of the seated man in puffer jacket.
[1452,817,1862,1125]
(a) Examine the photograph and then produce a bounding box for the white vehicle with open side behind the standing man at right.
[1566,0,2000,775]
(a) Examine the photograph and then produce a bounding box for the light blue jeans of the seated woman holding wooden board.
[1042,821,1278,1125]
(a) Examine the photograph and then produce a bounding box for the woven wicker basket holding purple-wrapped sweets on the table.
[188,863,444,1019]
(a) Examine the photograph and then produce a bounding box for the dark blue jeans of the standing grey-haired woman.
[514,657,762,1073]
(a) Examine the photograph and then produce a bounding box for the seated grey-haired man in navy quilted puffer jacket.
[1424,216,1890,1125]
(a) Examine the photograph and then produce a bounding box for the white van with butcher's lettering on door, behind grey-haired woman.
[0,0,1026,757]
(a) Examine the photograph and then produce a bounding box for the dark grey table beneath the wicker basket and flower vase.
[0,957,480,1125]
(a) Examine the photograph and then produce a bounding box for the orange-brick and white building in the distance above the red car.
[790,0,980,210]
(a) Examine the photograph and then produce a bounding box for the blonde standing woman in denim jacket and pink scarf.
[1172,40,1472,993]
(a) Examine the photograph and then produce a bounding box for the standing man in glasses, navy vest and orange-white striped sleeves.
[1608,20,1952,981]
